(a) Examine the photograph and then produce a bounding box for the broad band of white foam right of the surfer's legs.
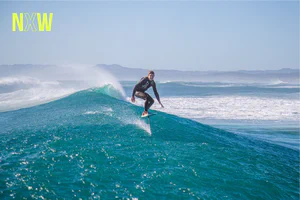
[152,96,300,121]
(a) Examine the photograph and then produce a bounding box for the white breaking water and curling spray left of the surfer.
[0,65,125,112]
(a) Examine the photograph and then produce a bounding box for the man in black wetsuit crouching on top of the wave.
[131,71,164,116]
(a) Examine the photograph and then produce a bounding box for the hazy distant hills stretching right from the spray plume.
[97,64,299,84]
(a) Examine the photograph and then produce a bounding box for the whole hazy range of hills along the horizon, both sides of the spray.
[0,64,300,84]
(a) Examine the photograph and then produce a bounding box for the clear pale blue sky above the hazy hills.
[0,1,300,71]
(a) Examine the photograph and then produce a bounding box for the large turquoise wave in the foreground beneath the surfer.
[0,87,300,199]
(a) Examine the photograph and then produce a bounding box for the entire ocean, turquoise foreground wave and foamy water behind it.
[0,77,300,200]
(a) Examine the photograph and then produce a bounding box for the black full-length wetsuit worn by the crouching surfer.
[132,76,160,111]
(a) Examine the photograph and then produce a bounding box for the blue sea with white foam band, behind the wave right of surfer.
[123,82,300,150]
